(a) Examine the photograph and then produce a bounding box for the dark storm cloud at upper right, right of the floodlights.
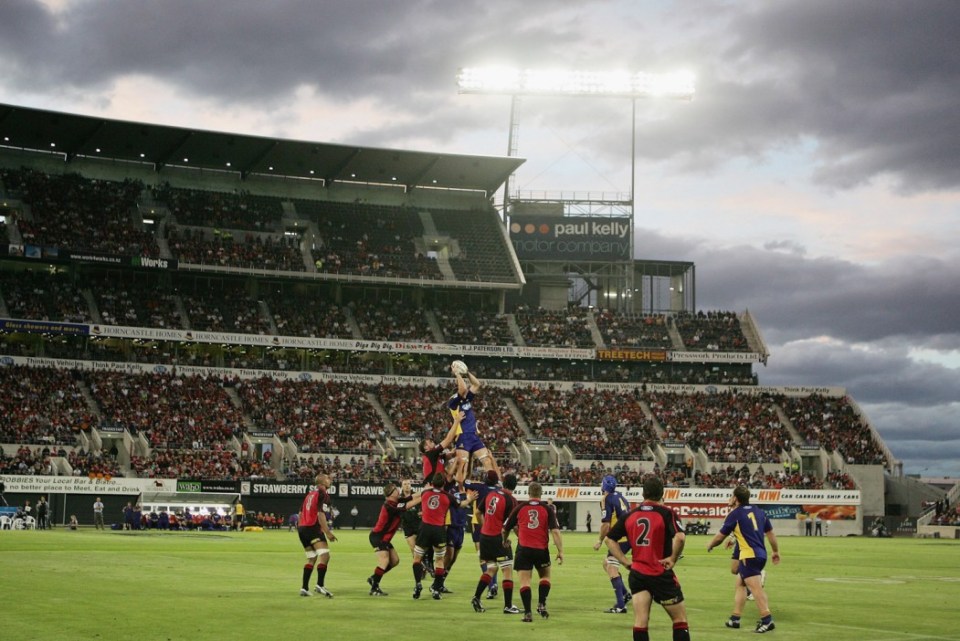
[639,0,960,192]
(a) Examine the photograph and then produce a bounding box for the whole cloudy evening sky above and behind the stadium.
[0,0,960,477]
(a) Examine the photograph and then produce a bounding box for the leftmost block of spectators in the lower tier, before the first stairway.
[0,365,96,445]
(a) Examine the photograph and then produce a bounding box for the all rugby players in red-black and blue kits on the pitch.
[298,367,780,641]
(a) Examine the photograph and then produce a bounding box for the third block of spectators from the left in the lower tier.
[237,378,387,453]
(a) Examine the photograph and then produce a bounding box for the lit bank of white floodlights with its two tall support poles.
[457,67,695,215]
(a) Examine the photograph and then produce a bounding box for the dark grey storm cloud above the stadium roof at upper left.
[0,0,564,109]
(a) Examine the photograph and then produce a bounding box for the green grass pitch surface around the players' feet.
[0,529,960,641]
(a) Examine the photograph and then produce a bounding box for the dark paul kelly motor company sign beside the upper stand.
[510,215,632,261]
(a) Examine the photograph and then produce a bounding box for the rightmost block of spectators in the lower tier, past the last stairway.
[778,394,886,465]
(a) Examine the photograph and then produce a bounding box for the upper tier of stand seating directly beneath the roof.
[0,168,521,286]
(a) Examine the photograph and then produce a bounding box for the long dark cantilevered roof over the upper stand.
[0,104,524,195]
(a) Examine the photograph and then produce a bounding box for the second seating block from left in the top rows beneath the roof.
[153,183,283,231]
